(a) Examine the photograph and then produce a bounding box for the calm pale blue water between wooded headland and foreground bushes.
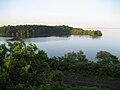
[0,29,120,60]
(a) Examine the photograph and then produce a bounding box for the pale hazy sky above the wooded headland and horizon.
[0,0,120,27]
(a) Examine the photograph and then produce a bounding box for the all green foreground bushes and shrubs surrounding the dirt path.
[0,40,120,90]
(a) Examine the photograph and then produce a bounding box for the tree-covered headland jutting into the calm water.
[0,25,102,39]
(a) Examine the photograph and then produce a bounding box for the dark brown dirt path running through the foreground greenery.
[64,75,120,90]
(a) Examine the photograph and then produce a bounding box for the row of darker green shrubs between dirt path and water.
[50,51,120,79]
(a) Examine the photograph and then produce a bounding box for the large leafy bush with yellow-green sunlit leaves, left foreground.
[0,42,63,90]
